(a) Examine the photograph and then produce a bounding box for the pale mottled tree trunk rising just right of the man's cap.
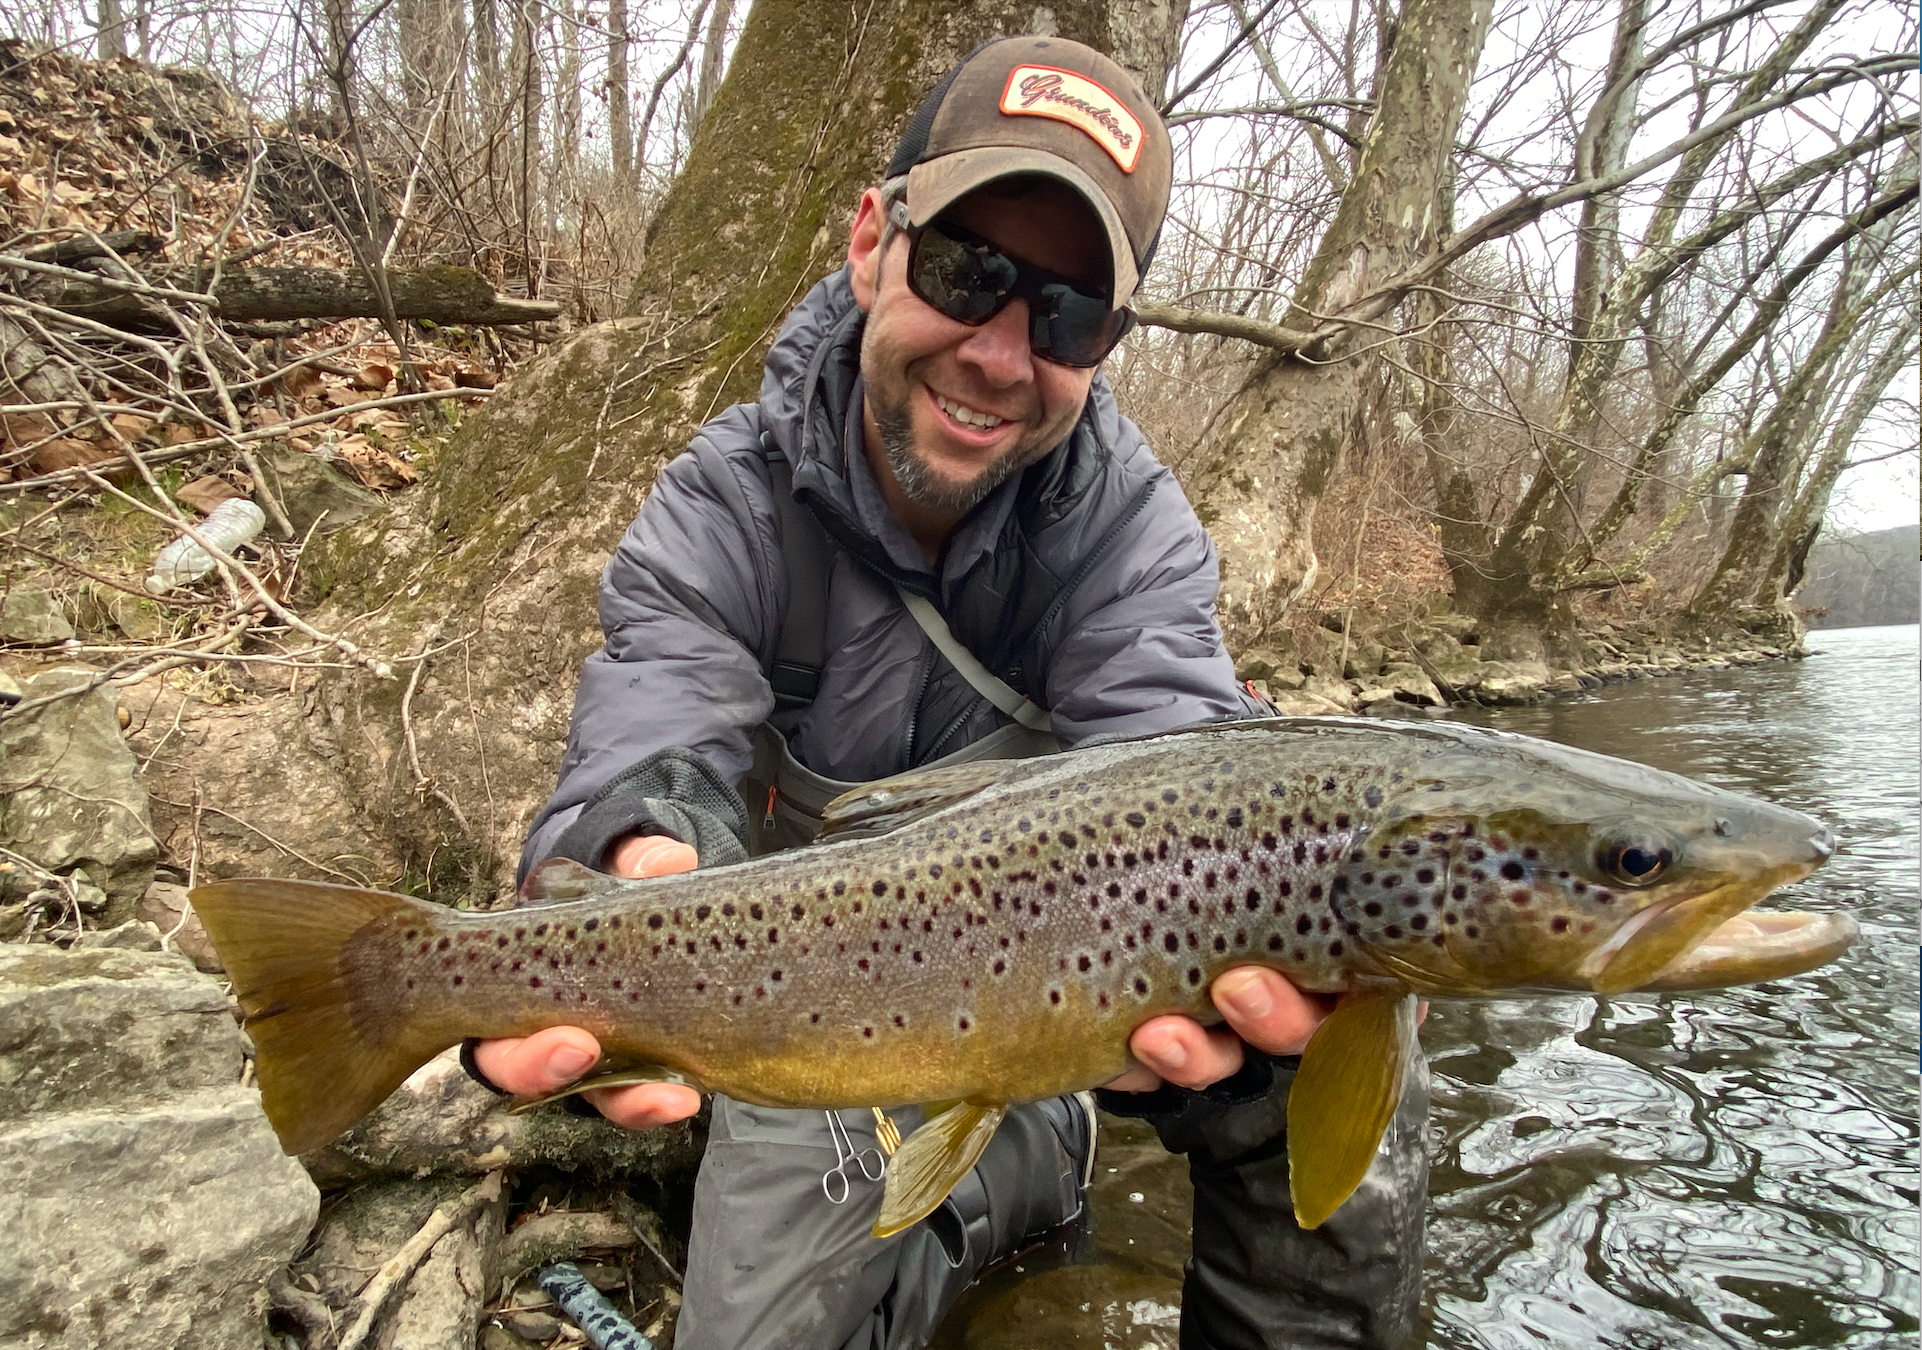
[1188,0,1491,642]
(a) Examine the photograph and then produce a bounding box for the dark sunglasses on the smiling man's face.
[888,202,1134,369]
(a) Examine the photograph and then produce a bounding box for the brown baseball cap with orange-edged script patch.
[888,37,1174,304]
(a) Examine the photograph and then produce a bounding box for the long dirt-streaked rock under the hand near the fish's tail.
[302,1050,703,1188]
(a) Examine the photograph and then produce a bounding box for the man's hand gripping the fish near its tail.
[475,835,702,1129]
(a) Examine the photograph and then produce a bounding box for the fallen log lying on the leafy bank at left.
[15,256,561,329]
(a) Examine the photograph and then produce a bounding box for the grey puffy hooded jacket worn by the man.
[523,273,1249,867]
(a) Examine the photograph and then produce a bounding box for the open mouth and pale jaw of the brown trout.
[1582,850,1855,994]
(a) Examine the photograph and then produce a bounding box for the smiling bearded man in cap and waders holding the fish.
[471,38,1426,1350]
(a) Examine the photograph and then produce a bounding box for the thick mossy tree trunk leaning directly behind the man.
[306,0,1172,896]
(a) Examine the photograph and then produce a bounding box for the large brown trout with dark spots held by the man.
[192,717,1857,1237]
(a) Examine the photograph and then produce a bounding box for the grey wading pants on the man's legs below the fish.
[675,1060,1428,1350]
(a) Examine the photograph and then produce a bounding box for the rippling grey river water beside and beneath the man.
[938,627,1922,1350]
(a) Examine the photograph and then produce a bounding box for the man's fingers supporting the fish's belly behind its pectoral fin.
[1107,965,1334,1092]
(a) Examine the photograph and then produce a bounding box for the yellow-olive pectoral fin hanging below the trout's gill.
[1288,987,1420,1229]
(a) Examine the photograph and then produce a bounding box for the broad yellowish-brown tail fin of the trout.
[190,881,457,1154]
